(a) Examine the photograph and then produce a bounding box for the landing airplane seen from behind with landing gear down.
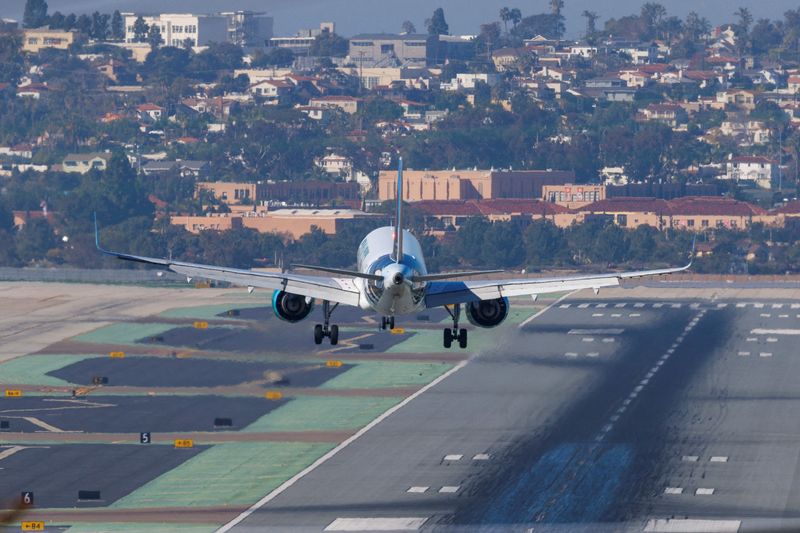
[95,158,692,349]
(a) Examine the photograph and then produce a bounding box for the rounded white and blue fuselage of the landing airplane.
[356,226,428,316]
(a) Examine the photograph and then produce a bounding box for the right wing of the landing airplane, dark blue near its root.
[425,263,691,308]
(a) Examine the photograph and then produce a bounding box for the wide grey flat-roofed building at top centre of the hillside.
[348,33,437,67]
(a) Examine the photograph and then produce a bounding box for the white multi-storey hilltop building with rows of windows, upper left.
[122,13,228,47]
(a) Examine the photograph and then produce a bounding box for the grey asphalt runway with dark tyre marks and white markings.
[219,299,800,532]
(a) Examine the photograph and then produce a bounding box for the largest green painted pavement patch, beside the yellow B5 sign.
[111,442,336,508]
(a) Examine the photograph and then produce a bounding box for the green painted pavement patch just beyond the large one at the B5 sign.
[242,396,402,433]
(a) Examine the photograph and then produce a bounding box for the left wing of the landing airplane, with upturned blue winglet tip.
[98,247,361,305]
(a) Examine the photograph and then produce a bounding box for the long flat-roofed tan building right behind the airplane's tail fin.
[378,169,575,202]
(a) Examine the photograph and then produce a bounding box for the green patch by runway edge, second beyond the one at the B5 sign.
[321,361,453,389]
